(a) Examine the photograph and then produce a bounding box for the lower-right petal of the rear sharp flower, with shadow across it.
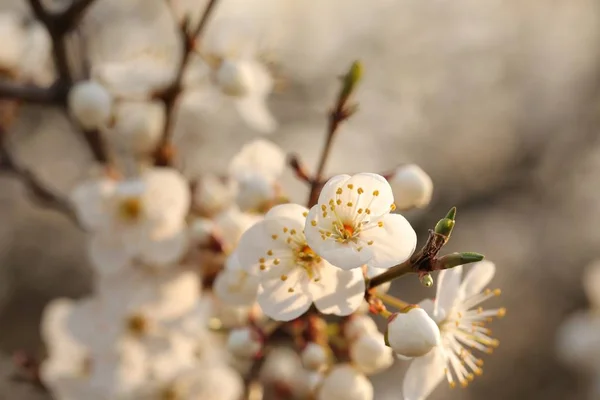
[310,261,365,316]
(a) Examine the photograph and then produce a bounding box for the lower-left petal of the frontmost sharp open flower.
[304,205,372,270]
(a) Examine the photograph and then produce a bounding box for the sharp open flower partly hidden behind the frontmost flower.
[236,204,365,321]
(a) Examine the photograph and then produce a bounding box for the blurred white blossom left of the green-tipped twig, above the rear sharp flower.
[229,139,285,210]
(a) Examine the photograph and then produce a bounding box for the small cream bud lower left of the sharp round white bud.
[350,332,394,374]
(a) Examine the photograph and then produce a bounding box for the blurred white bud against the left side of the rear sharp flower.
[213,253,259,306]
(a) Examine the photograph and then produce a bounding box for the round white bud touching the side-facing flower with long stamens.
[386,307,440,357]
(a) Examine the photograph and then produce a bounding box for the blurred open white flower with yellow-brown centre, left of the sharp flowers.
[72,168,190,274]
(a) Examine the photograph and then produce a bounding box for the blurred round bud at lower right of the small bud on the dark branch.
[109,101,165,154]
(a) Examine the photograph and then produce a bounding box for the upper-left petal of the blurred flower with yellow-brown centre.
[71,179,115,230]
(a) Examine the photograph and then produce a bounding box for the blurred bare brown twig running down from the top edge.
[154,0,217,166]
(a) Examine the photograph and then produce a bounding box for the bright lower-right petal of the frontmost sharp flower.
[360,214,417,268]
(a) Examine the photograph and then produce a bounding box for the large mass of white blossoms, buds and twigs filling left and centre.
[0,1,505,400]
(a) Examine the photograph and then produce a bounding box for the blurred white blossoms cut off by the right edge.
[557,261,600,399]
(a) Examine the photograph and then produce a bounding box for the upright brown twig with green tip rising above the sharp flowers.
[308,61,362,207]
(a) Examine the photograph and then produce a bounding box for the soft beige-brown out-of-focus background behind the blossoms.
[0,0,600,400]
